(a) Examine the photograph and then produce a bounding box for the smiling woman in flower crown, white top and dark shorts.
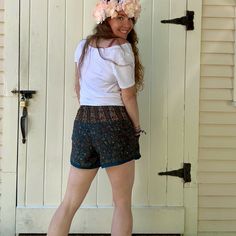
[48,0,143,236]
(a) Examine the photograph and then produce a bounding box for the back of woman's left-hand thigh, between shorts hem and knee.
[63,166,98,210]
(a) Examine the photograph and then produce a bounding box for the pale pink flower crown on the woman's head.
[93,0,141,24]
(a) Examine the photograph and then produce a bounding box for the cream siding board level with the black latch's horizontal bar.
[200,89,233,101]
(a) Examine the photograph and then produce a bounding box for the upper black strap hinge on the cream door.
[161,11,194,30]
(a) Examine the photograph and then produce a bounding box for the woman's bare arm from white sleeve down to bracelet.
[121,86,140,130]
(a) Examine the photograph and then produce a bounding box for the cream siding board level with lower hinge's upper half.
[198,159,236,173]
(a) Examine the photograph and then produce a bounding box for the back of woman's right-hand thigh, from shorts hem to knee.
[106,160,135,205]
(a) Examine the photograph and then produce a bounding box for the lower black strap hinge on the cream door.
[158,163,191,183]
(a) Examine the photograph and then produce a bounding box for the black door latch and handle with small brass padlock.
[11,90,36,143]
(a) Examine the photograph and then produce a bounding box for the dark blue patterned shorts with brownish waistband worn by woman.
[70,106,141,169]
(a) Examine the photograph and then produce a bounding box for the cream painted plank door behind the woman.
[16,0,187,233]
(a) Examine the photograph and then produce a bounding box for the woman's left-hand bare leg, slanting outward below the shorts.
[47,166,98,236]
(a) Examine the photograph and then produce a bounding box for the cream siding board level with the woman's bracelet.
[200,124,236,137]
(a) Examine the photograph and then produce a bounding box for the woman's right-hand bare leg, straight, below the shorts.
[106,160,135,236]
